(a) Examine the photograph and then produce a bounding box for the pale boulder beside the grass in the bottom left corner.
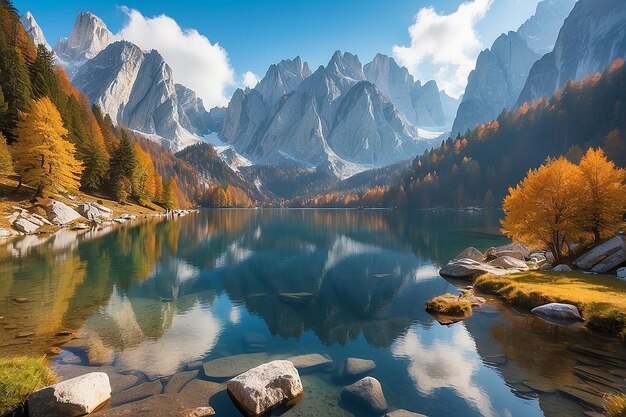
[27,372,111,417]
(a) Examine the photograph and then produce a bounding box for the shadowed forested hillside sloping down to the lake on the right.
[298,60,626,208]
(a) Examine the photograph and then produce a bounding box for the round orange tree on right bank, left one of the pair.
[502,157,583,262]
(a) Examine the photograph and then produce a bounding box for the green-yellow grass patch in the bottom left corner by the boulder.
[0,357,56,415]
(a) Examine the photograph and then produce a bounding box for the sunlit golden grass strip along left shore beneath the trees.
[0,175,165,232]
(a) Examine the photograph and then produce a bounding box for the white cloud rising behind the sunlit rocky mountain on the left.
[116,7,235,108]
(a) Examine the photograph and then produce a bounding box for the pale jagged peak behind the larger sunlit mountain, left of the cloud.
[54,12,113,78]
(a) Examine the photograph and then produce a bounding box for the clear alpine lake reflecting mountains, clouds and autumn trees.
[0,209,626,417]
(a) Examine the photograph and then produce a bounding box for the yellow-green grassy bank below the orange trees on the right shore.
[474,271,626,339]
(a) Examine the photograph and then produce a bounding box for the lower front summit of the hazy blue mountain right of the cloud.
[452,32,539,137]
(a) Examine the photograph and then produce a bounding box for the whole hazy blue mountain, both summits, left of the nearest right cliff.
[451,0,575,136]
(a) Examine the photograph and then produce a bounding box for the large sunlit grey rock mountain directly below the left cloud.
[72,41,200,151]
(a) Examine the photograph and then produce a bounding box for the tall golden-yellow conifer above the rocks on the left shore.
[13,97,83,196]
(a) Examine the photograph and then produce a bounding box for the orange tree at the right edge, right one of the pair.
[578,148,626,242]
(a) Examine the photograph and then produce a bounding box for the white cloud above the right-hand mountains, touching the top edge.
[393,0,493,97]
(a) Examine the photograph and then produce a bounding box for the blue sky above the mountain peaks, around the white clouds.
[14,0,538,106]
